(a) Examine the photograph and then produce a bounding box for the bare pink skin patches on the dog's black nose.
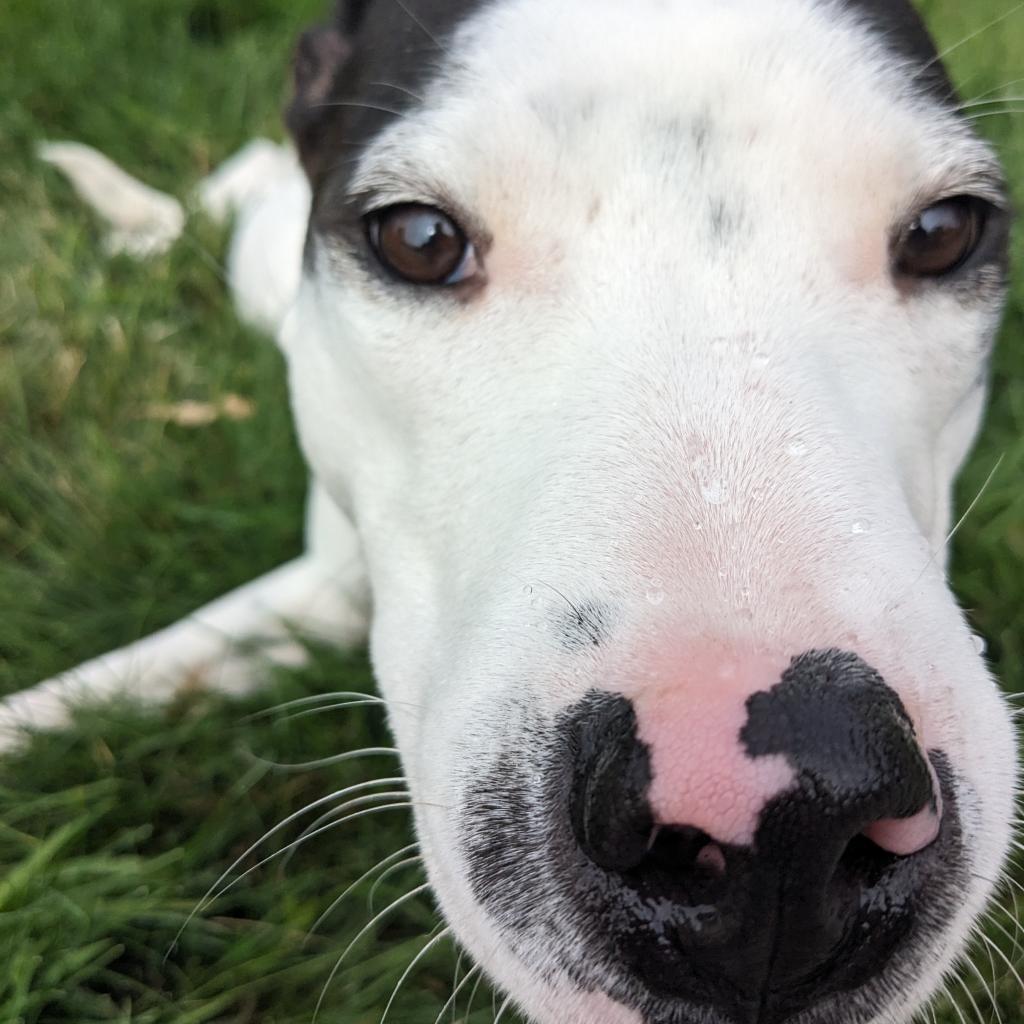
[633,652,941,855]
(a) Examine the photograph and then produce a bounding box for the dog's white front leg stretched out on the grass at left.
[0,481,369,751]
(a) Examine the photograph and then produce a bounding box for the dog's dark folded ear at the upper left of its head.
[285,0,371,181]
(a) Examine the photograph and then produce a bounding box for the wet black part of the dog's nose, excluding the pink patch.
[567,651,941,1024]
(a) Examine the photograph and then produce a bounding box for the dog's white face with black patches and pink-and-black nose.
[285,0,1015,1024]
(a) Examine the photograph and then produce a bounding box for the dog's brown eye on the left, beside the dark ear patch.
[367,203,476,285]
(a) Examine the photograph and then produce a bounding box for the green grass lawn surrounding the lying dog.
[0,0,1024,1024]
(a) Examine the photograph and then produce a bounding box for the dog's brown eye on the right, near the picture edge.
[896,196,988,278]
